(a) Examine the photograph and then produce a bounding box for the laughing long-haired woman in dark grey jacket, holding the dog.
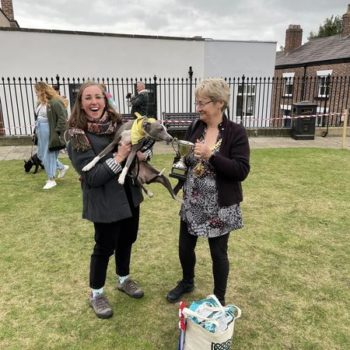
[67,82,144,318]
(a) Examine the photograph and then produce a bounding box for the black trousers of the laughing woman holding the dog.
[90,207,140,289]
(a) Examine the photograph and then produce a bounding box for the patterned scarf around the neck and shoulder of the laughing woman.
[67,114,119,152]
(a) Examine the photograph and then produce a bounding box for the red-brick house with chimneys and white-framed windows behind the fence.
[272,5,350,127]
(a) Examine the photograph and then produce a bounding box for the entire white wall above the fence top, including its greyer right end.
[0,30,276,78]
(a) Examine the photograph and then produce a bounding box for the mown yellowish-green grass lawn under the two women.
[0,148,350,350]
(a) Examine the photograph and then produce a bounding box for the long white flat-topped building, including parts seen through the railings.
[0,27,276,135]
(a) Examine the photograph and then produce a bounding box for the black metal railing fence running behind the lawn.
[0,74,350,136]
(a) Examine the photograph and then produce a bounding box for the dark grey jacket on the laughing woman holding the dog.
[67,133,143,223]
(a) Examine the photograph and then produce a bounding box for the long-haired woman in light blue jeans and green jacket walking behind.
[34,81,69,190]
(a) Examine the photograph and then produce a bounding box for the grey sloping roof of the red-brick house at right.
[276,34,350,68]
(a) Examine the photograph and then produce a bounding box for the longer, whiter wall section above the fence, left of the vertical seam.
[0,30,204,78]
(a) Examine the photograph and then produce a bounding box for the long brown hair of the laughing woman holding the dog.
[68,81,122,130]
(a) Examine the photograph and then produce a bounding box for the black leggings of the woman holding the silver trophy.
[179,220,230,300]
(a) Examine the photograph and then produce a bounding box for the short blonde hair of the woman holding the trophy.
[195,78,230,111]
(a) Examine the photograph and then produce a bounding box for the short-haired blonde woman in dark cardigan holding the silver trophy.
[167,79,250,305]
